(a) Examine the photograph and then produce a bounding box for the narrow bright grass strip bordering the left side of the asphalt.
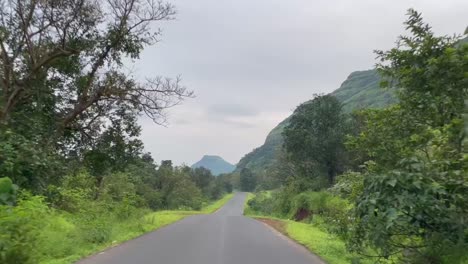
[39,193,234,264]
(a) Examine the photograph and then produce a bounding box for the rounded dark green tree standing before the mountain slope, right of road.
[283,95,346,184]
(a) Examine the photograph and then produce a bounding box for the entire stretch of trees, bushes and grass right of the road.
[245,10,468,263]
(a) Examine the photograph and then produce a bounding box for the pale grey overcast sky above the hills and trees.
[131,0,468,165]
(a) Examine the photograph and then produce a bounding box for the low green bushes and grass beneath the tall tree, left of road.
[0,159,232,263]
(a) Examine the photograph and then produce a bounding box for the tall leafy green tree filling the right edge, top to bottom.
[349,10,468,263]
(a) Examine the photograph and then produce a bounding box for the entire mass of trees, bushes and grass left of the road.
[0,0,232,263]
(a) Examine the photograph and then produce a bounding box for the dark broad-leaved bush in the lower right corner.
[352,139,468,263]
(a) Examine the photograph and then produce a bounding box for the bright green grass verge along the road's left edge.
[38,194,233,264]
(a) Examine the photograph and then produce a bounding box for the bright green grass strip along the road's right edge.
[244,194,373,264]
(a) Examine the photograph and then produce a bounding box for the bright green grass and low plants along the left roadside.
[0,190,232,264]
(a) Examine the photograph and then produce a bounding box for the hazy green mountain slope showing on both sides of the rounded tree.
[236,70,396,172]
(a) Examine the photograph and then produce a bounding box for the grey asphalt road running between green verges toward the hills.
[78,193,323,264]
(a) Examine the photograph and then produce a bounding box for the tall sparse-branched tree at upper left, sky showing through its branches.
[0,0,192,190]
